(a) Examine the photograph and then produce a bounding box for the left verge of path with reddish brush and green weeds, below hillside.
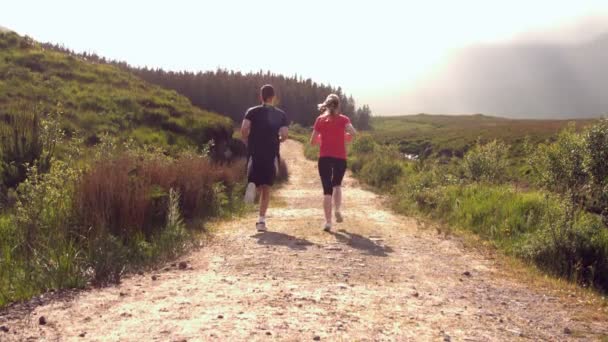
[0,139,244,306]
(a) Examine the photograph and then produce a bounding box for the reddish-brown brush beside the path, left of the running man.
[76,148,240,239]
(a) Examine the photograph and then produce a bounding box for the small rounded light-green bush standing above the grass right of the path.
[462,140,508,183]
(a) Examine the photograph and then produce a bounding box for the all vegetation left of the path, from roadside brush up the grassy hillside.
[0,32,254,307]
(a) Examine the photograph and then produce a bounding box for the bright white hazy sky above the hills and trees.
[0,0,608,114]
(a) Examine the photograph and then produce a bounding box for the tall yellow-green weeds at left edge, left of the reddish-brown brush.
[0,161,86,301]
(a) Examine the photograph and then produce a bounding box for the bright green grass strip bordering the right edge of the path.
[393,180,608,293]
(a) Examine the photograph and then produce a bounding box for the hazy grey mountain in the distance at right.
[406,34,608,118]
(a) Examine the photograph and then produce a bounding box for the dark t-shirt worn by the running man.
[245,105,289,158]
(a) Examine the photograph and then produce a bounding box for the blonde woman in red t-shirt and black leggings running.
[310,94,357,231]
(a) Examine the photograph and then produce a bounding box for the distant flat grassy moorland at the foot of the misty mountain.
[372,114,593,156]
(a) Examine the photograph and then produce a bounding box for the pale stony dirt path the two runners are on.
[0,141,608,341]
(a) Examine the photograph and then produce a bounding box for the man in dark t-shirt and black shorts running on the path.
[241,84,289,232]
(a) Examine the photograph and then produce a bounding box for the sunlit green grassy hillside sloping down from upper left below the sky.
[0,32,231,146]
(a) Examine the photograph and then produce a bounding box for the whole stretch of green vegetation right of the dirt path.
[298,116,608,292]
